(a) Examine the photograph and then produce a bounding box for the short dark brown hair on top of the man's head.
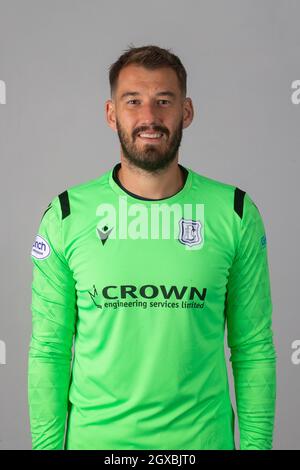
[109,44,187,97]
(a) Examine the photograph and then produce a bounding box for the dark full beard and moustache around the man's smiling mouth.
[116,119,183,173]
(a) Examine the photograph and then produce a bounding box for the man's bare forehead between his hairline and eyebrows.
[117,64,180,96]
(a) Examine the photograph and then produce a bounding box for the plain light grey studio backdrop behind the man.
[0,0,300,449]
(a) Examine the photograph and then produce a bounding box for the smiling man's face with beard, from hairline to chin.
[107,65,193,172]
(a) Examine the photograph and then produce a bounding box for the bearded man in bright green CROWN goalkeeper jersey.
[28,45,276,449]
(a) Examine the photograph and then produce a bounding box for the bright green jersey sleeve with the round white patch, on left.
[28,197,77,450]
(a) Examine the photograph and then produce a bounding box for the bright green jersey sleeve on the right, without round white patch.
[225,193,277,450]
